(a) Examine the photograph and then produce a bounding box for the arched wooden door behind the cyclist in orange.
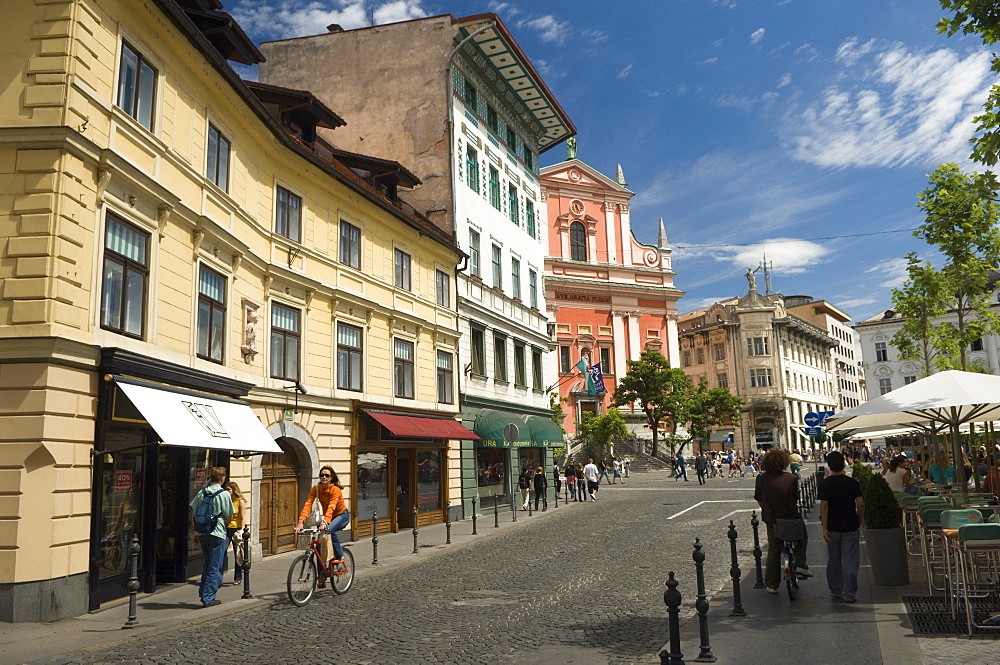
[260,441,301,556]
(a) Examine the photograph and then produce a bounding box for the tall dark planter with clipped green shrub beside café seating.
[864,473,910,586]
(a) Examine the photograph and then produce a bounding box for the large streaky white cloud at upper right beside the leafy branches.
[783,39,995,168]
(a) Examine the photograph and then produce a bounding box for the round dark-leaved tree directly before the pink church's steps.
[612,349,694,457]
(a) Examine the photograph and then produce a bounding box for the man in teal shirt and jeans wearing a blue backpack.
[191,466,233,607]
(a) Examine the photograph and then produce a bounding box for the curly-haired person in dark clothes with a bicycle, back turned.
[753,448,812,593]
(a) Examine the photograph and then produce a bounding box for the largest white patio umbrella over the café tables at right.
[826,370,1000,489]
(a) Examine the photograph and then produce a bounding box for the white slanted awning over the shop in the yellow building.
[115,377,281,453]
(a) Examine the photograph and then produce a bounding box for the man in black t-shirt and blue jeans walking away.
[816,452,865,603]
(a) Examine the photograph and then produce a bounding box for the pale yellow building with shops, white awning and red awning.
[0,0,474,621]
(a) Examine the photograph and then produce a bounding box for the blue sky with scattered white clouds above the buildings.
[224,0,996,321]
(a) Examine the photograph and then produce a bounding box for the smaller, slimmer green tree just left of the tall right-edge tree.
[892,252,948,376]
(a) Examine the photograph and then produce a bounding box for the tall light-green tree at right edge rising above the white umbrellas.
[913,164,1000,371]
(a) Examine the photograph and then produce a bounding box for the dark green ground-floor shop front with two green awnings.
[461,395,565,518]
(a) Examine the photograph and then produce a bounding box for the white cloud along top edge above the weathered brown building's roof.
[231,0,427,40]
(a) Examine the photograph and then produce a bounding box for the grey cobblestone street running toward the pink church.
[41,472,755,665]
